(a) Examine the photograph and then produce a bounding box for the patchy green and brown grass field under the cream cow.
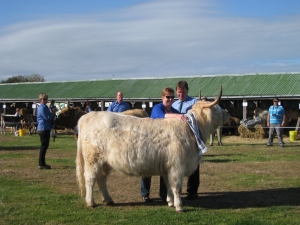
[0,134,300,225]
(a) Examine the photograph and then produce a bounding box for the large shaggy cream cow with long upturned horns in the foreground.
[76,89,230,212]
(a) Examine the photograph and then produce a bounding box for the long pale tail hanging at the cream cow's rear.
[76,135,85,196]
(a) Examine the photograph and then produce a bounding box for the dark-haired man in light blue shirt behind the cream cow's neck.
[172,81,200,200]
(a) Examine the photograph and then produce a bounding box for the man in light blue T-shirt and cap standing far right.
[267,98,285,147]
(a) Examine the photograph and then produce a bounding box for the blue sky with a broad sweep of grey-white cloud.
[0,0,300,81]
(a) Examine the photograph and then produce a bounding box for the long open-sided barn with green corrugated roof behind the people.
[0,73,300,129]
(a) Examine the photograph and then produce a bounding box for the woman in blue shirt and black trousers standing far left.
[37,93,55,169]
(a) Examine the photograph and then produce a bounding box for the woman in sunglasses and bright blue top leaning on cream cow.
[141,87,186,202]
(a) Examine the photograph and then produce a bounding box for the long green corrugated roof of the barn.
[0,73,300,101]
